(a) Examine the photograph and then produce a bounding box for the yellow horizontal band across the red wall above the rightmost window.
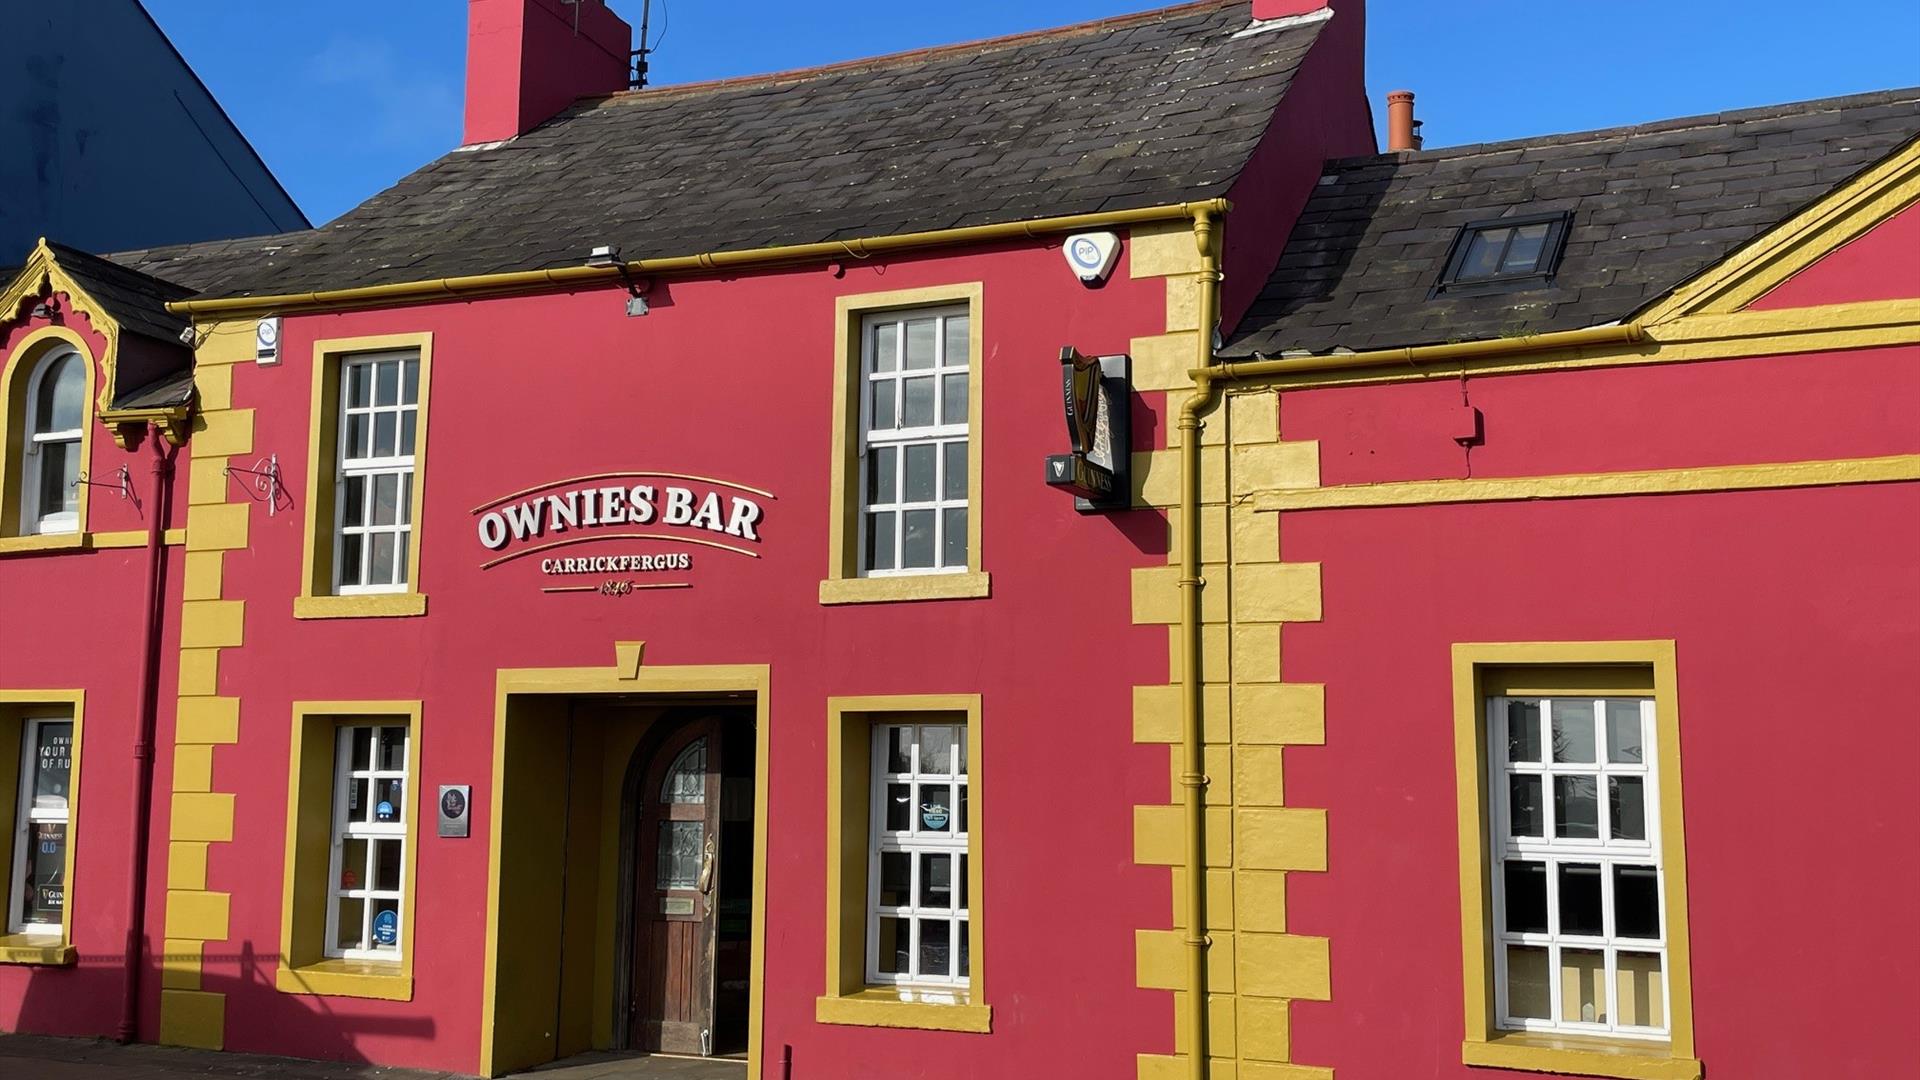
[1252,454,1920,511]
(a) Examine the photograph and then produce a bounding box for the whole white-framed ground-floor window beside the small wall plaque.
[326,724,409,961]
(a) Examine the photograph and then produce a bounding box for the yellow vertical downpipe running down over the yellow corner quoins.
[1177,206,1225,1080]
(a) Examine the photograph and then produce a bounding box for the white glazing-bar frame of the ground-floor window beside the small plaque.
[323,721,413,963]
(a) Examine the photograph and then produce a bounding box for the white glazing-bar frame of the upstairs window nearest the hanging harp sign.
[854,304,977,578]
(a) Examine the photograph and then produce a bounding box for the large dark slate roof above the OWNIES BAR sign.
[115,0,1325,296]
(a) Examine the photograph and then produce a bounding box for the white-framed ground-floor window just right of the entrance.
[866,724,972,990]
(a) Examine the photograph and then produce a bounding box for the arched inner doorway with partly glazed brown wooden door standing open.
[616,703,756,1057]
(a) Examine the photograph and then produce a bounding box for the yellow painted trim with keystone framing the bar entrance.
[478,657,772,1076]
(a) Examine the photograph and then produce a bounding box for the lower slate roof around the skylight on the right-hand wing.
[1221,88,1920,357]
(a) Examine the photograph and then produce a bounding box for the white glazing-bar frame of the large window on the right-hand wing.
[1486,694,1672,1042]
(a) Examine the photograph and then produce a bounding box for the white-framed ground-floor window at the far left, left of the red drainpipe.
[6,713,73,934]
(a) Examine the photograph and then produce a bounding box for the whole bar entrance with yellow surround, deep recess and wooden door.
[476,661,768,1076]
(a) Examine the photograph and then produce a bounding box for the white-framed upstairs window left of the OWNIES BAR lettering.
[334,352,420,596]
